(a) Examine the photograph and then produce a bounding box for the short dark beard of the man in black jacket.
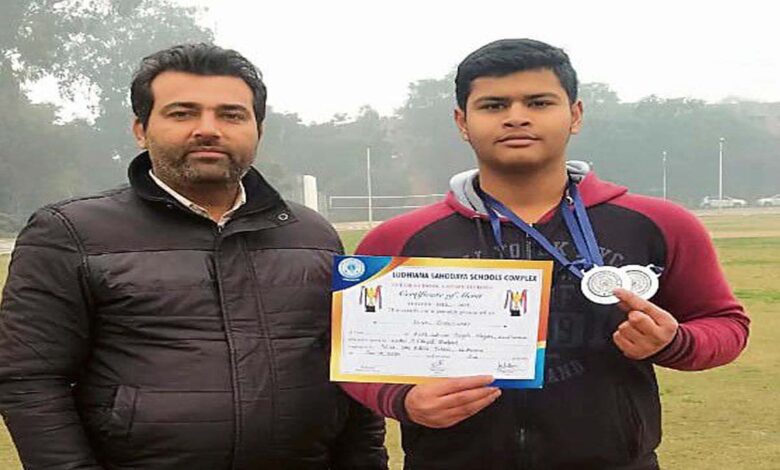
[149,142,252,186]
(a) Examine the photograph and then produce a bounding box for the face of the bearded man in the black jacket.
[133,71,260,188]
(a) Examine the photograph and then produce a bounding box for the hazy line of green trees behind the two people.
[0,0,780,232]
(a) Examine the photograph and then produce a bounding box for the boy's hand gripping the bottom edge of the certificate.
[404,375,501,428]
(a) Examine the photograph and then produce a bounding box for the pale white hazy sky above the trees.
[32,0,780,121]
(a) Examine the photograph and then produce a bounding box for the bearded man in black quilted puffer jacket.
[0,44,387,470]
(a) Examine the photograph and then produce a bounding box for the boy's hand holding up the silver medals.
[612,289,678,360]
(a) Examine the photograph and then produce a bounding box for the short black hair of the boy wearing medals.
[455,39,577,111]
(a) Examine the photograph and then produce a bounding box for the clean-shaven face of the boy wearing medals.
[455,69,582,173]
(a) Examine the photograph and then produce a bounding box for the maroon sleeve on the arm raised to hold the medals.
[615,196,750,370]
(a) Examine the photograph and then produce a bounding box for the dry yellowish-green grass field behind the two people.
[0,214,780,470]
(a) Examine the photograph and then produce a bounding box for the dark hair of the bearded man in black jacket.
[130,43,268,129]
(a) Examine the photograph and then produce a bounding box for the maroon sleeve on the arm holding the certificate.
[339,202,452,422]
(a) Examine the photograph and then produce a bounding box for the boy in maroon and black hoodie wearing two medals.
[343,39,749,470]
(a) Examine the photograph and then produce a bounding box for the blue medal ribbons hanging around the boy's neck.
[479,182,604,279]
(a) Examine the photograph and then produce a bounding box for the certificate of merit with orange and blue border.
[330,256,552,388]
